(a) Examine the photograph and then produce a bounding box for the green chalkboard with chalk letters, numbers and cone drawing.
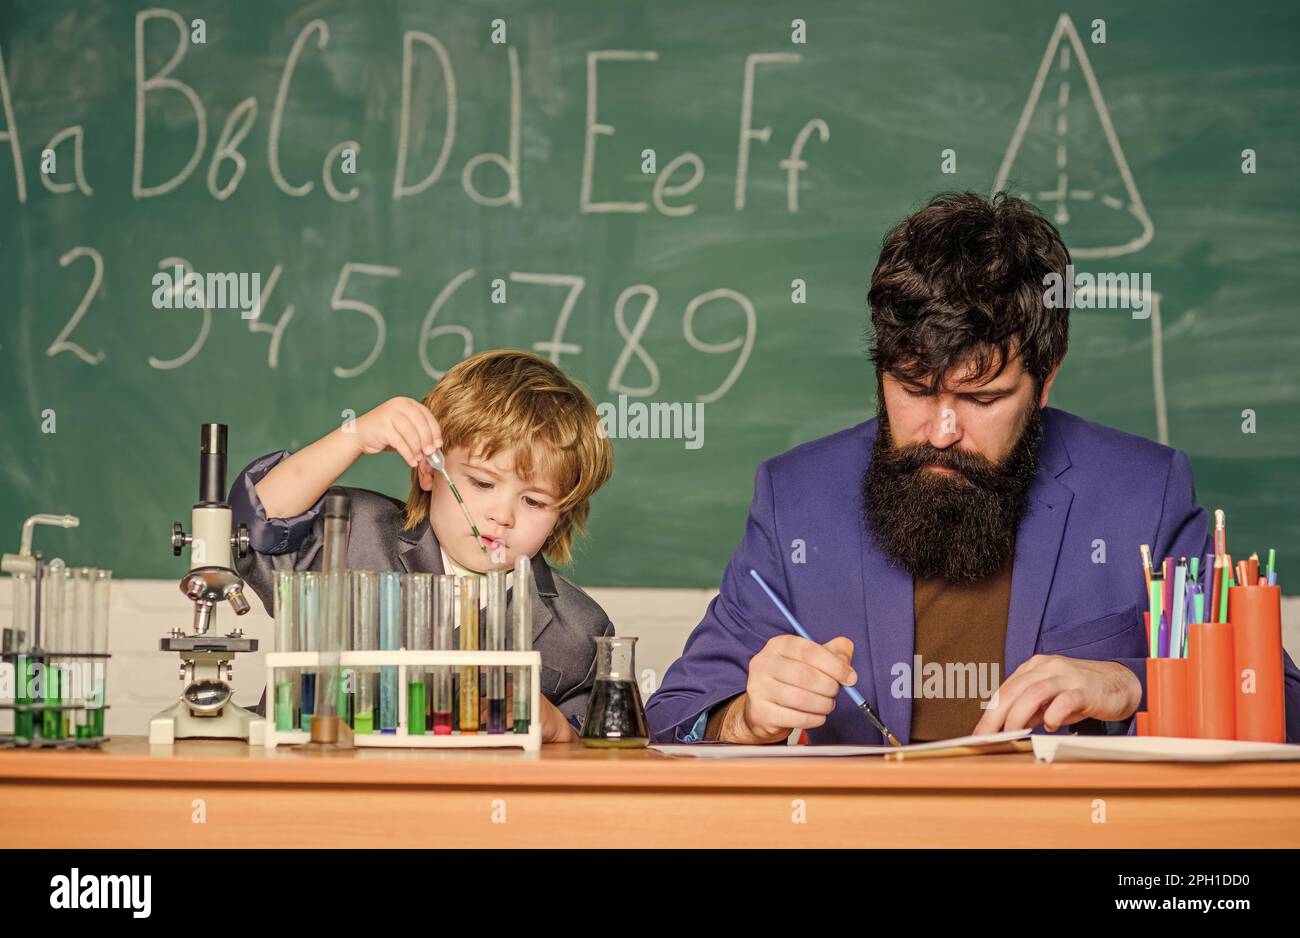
[0,0,1300,587]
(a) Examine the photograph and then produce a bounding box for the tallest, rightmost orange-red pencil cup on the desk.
[1227,586,1287,743]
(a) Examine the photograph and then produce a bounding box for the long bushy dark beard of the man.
[862,401,1043,583]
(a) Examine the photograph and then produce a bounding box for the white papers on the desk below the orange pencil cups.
[1034,735,1300,763]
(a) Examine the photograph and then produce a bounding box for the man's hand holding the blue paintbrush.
[719,635,858,744]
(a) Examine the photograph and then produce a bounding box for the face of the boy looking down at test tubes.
[420,446,560,573]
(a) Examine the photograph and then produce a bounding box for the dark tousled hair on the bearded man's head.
[867,192,1070,392]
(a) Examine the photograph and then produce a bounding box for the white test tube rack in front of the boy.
[256,648,542,752]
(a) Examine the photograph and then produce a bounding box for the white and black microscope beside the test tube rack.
[150,424,259,746]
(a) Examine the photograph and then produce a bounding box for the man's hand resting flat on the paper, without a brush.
[975,655,1141,735]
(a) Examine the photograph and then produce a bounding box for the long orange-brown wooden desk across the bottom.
[0,737,1300,848]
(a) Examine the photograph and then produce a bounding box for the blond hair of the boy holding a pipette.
[403,348,614,564]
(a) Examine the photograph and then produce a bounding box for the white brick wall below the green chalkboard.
[0,577,1300,735]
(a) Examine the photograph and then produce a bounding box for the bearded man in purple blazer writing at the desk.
[646,194,1300,743]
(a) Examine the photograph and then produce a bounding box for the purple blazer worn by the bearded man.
[646,408,1300,743]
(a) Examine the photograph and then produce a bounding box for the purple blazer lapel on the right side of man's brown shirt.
[1002,409,1074,681]
